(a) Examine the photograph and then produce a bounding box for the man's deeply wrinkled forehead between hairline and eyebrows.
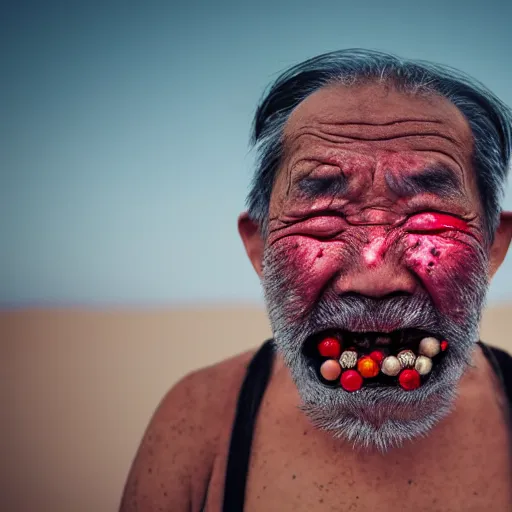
[284,83,473,173]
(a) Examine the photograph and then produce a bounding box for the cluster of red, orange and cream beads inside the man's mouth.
[317,335,448,391]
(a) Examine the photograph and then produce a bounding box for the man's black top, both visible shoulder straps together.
[222,340,512,512]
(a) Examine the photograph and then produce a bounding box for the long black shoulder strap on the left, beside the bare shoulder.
[222,340,274,512]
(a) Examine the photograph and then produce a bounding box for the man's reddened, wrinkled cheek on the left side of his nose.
[264,236,343,320]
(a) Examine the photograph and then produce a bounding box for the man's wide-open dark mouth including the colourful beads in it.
[303,329,448,391]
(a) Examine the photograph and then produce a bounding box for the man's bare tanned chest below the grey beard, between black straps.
[244,402,512,512]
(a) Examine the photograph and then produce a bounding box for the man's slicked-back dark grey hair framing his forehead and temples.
[247,49,512,242]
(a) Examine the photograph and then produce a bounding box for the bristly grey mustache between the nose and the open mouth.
[302,293,444,335]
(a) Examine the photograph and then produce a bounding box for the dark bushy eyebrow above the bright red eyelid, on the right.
[385,165,462,198]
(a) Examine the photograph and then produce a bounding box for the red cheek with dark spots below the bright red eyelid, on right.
[405,235,487,320]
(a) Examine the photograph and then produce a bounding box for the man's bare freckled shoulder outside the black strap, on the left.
[120,350,255,512]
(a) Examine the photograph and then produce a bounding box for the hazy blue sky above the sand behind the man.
[0,0,512,305]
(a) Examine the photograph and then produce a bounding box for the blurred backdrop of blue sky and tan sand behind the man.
[0,0,512,512]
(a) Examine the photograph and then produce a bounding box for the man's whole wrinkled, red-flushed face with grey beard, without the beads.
[263,85,488,449]
